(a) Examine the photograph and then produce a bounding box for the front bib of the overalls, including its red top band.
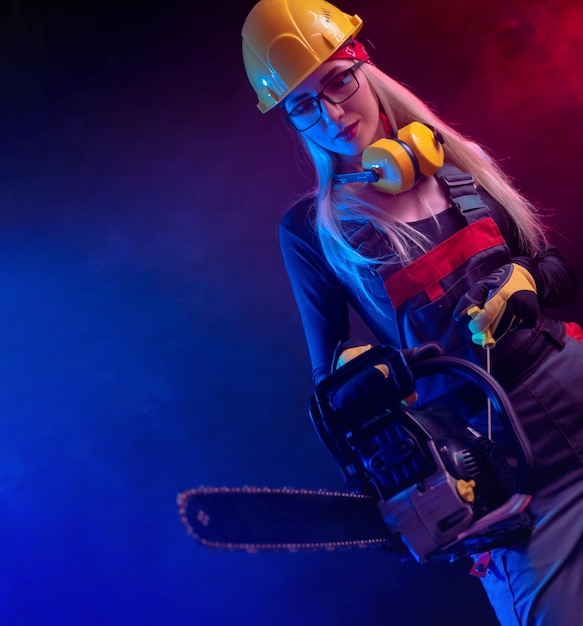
[381,217,510,358]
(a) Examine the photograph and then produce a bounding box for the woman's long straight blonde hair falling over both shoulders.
[298,64,546,298]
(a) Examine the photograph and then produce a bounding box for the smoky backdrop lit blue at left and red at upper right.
[0,0,583,626]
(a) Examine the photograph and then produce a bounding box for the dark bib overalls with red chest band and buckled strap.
[361,166,583,626]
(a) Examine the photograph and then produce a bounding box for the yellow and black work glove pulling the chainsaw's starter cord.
[454,263,539,346]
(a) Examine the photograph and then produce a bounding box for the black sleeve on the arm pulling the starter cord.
[480,190,578,308]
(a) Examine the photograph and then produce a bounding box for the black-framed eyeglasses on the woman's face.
[286,59,365,133]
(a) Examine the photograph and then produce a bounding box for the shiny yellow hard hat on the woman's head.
[241,0,362,113]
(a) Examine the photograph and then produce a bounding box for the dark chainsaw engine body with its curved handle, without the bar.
[310,348,532,562]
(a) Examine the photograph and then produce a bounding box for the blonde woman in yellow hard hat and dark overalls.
[242,0,583,626]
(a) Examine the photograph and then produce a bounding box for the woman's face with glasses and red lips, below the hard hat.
[284,59,385,171]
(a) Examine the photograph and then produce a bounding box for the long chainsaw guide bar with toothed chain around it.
[177,486,391,552]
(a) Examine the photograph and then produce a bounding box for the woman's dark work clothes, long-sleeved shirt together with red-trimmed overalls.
[280,165,583,626]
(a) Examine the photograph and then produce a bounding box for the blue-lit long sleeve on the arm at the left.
[279,206,350,384]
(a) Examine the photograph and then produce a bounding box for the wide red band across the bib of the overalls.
[385,217,506,308]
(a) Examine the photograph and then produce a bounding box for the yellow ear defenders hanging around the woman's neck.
[334,122,444,194]
